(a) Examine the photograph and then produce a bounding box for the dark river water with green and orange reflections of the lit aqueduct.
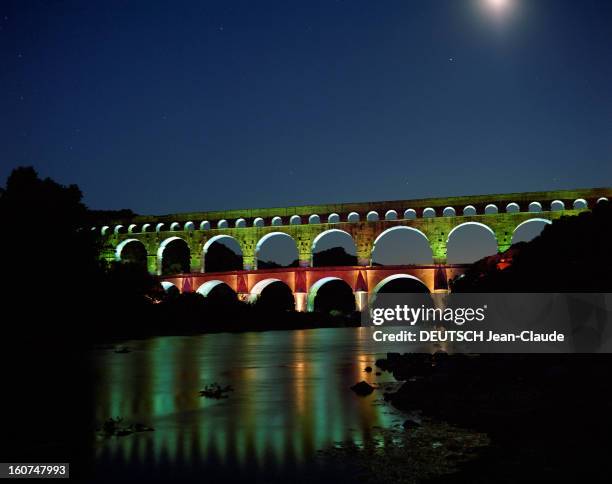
[94,328,403,481]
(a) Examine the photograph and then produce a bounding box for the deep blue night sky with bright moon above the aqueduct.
[0,0,612,213]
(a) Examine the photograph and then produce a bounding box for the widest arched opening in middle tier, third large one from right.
[372,226,433,266]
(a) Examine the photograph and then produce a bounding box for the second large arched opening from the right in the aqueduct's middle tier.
[446,222,497,264]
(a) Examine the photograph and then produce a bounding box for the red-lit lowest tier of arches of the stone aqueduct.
[162,264,467,311]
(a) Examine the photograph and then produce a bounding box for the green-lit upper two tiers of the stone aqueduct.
[99,188,612,274]
